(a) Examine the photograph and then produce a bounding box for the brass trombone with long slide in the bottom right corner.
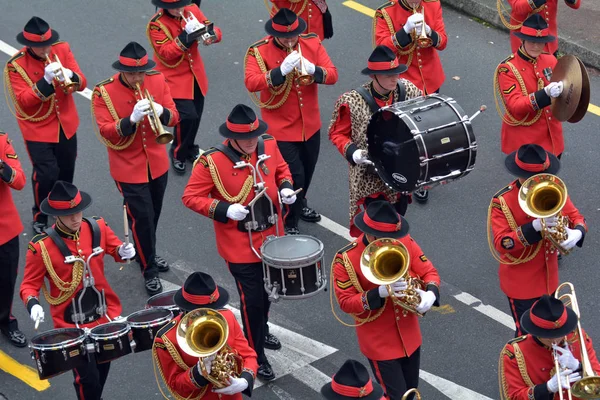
[554,282,600,400]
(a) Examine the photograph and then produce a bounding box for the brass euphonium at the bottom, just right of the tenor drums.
[176,308,239,388]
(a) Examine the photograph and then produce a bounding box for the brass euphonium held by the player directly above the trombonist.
[519,174,571,255]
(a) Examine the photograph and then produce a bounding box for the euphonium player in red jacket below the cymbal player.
[488,144,587,337]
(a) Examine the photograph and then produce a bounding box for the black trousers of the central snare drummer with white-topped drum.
[227,262,271,364]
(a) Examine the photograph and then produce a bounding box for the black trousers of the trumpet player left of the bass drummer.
[277,129,321,228]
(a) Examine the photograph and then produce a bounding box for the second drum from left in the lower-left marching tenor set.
[90,322,133,364]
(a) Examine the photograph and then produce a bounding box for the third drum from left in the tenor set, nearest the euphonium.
[127,308,173,353]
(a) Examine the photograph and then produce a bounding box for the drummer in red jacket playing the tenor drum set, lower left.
[21,181,135,400]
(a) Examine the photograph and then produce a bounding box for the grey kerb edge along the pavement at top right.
[442,0,600,69]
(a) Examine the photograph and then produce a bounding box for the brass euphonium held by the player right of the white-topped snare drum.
[360,238,424,317]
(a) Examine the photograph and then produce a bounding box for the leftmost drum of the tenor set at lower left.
[29,328,88,379]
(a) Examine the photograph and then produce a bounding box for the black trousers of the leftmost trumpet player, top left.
[25,128,77,223]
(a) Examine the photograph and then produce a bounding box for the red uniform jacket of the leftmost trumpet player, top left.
[4,42,87,143]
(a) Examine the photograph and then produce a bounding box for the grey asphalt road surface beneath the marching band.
[0,0,600,400]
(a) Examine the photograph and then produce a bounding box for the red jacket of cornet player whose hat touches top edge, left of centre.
[146,4,222,100]
